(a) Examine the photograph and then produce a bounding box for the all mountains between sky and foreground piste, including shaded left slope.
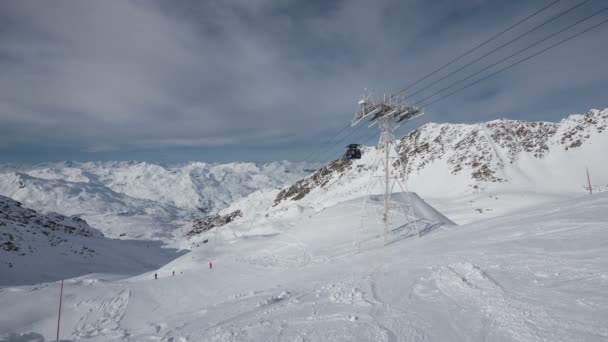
[0,109,608,286]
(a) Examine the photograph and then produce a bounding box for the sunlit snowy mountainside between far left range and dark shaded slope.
[0,172,187,240]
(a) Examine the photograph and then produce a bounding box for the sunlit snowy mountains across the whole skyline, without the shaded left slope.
[0,109,608,247]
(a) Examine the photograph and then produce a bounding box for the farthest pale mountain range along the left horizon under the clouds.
[13,161,306,212]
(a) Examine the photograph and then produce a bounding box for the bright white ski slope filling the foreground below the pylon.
[0,193,608,341]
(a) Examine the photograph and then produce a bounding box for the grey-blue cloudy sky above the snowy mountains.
[0,0,608,162]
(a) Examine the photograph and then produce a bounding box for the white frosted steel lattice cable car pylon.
[352,89,423,245]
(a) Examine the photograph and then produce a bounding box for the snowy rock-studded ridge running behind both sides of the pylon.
[275,109,608,205]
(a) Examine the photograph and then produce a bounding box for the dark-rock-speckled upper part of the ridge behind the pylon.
[274,109,608,206]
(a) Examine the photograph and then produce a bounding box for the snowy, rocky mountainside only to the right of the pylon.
[400,109,608,196]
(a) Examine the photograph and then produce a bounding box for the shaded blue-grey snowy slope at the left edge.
[0,196,177,286]
